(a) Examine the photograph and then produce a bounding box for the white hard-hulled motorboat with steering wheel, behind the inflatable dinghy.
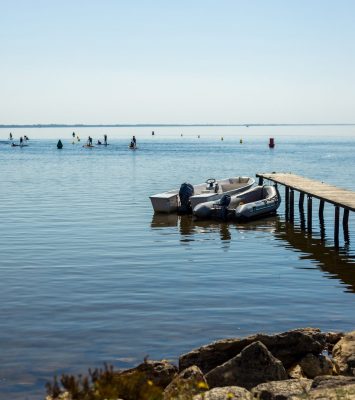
[149,176,255,213]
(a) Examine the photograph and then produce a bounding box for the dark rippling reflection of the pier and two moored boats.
[151,212,355,293]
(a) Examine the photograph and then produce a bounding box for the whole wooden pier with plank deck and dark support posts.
[256,172,355,247]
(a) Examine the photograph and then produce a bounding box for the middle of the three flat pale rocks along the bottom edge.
[251,379,312,400]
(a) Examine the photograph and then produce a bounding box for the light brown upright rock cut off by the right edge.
[333,331,355,375]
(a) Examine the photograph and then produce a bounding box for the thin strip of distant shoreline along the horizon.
[0,123,355,129]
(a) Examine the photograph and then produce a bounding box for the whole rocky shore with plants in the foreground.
[46,328,355,400]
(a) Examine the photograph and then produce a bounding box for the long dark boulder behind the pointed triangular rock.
[179,328,326,374]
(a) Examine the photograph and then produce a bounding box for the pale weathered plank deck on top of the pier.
[256,173,355,211]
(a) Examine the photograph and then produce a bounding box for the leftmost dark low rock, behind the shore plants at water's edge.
[119,360,177,389]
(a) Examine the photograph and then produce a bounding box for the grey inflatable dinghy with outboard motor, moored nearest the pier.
[193,185,281,220]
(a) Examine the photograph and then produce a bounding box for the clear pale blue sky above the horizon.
[0,0,355,124]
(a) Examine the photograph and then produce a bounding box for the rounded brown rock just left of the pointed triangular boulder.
[163,365,208,400]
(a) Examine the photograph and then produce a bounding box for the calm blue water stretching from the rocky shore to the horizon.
[0,127,355,399]
